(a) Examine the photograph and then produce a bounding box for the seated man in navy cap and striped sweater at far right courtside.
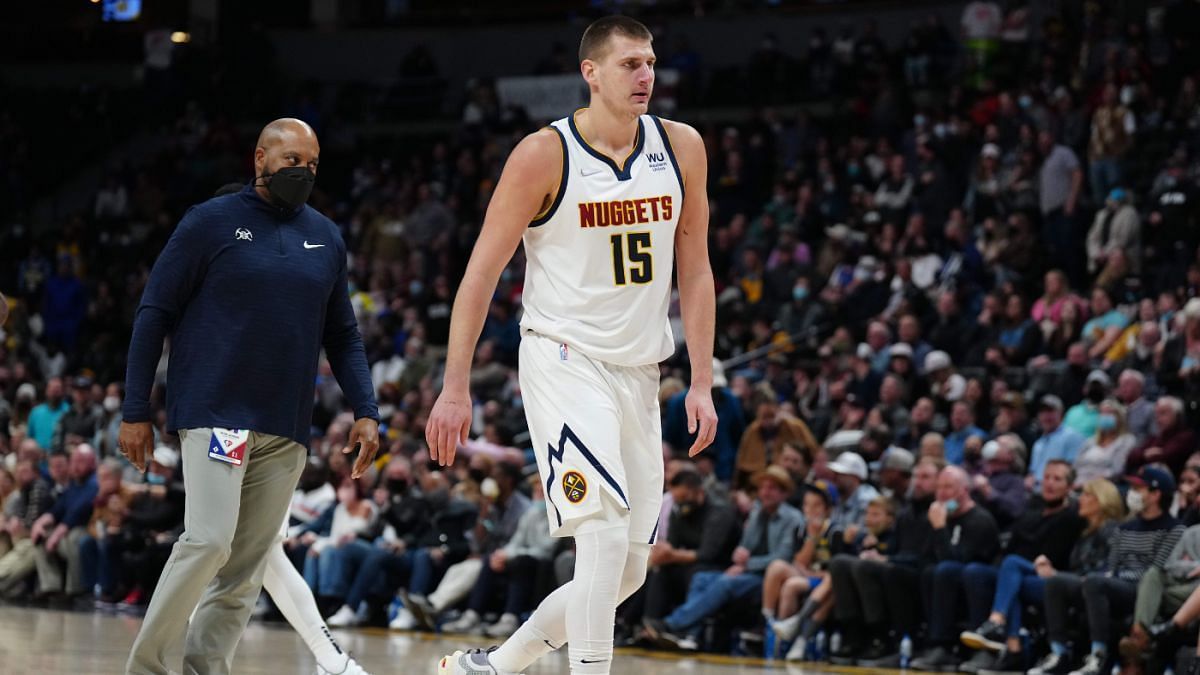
[1075,466,1183,675]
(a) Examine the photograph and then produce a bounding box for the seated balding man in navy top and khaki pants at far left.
[30,443,97,598]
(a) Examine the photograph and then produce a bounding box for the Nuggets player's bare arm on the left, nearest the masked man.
[425,127,563,466]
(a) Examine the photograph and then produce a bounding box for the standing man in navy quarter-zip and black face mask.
[119,119,379,675]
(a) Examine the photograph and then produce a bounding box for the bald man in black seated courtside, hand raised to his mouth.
[912,466,1000,670]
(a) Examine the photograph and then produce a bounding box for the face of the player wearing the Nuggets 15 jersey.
[583,35,655,115]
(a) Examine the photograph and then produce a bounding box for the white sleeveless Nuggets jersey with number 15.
[521,113,683,365]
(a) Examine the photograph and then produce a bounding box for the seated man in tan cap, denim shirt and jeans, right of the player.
[646,465,804,650]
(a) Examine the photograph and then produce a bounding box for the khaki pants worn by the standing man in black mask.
[126,429,307,675]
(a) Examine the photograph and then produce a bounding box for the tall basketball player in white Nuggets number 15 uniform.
[425,17,716,675]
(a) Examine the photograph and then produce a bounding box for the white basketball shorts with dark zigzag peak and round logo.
[520,331,664,544]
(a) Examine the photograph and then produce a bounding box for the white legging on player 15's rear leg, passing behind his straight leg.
[491,526,650,673]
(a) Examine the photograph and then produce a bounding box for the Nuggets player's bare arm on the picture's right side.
[664,120,716,456]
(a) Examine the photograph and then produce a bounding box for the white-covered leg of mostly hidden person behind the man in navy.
[263,546,350,673]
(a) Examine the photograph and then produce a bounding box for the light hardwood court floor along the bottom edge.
[0,607,892,675]
